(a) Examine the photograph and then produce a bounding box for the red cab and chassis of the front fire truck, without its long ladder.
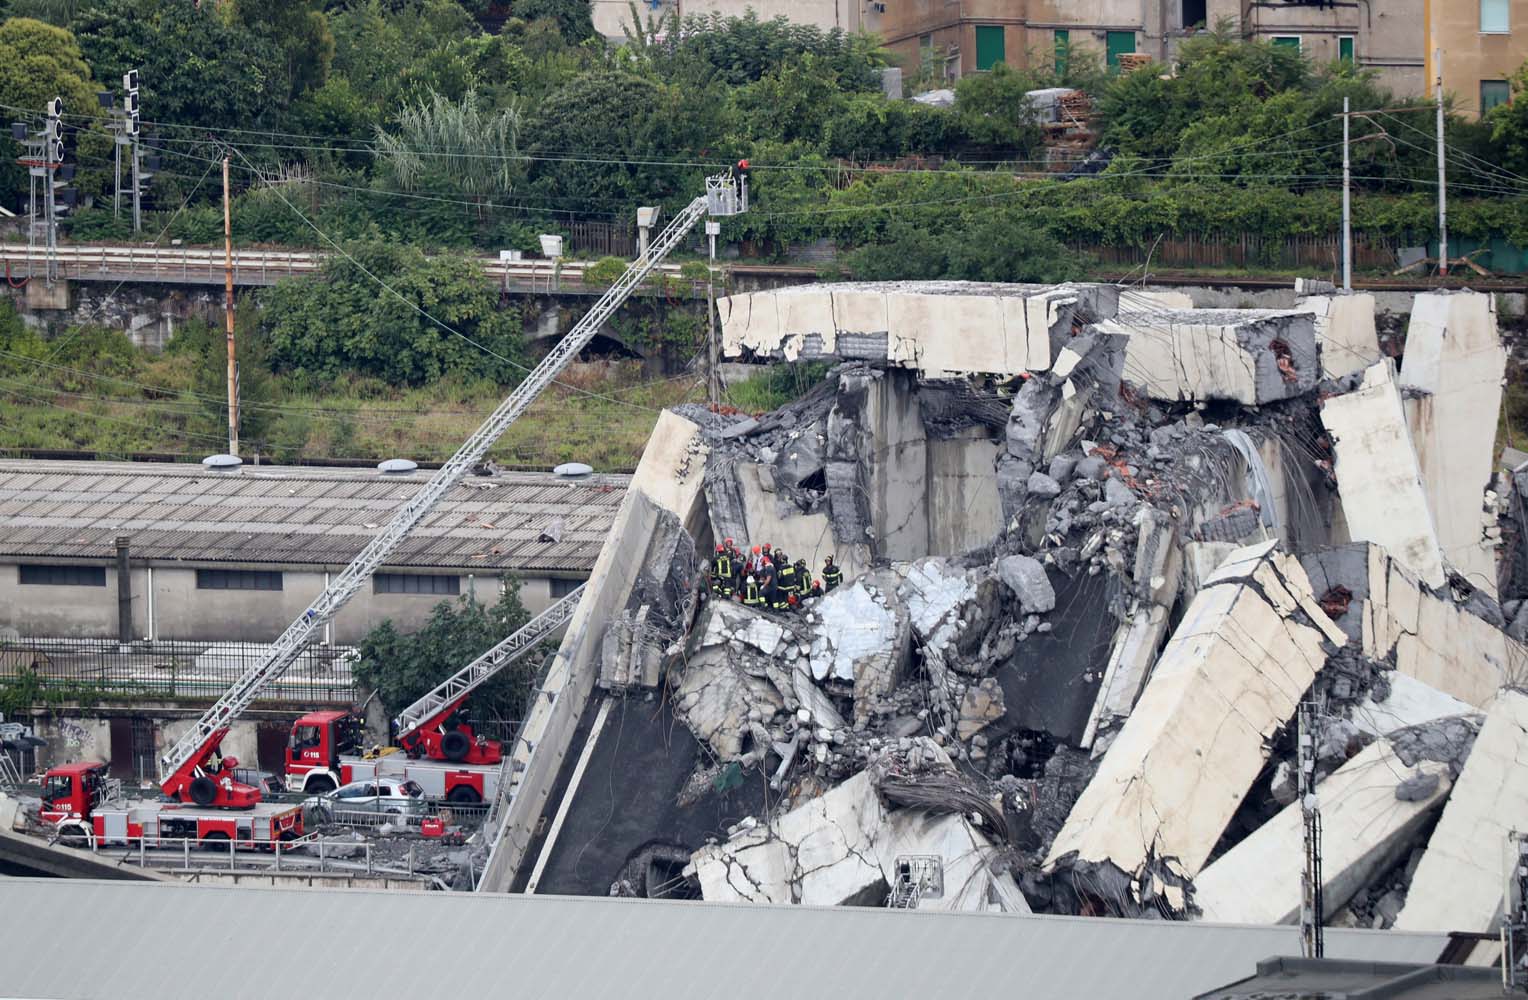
[41,757,303,850]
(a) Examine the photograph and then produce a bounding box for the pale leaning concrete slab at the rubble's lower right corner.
[1395,690,1528,933]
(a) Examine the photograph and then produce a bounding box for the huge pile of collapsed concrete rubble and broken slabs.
[574,283,1528,931]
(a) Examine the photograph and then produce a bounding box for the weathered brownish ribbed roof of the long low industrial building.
[0,462,631,572]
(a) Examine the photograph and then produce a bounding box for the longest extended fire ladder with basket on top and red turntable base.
[159,174,749,809]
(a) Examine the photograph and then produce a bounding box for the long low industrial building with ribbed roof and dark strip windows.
[0,460,628,645]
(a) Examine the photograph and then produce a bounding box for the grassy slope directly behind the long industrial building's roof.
[0,300,704,471]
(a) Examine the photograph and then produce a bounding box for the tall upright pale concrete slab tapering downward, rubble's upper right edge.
[1400,291,1507,598]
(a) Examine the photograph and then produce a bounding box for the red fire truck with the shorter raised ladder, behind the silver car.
[286,584,584,803]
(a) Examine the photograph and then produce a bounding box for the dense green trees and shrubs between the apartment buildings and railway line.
[0,0,1528,272]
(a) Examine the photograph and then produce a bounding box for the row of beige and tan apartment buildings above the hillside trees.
[593,0,1528,115]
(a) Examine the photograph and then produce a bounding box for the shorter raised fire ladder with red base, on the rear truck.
[393,584,584,765]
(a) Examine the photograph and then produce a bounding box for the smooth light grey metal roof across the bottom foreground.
[0,879,1447,1000]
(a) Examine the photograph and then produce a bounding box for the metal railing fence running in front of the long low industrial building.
[0,639,356,706]
